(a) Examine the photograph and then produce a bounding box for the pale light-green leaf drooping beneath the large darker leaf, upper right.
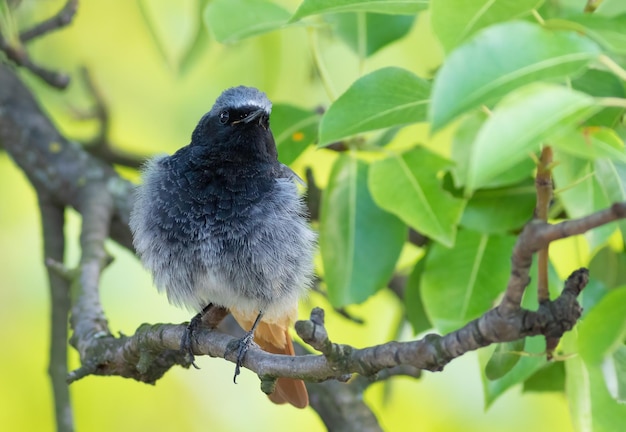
[465,84,598,193]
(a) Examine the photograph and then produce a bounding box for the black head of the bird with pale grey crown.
[191,86,277,160]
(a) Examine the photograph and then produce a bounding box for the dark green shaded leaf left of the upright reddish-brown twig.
[461,179,536,234]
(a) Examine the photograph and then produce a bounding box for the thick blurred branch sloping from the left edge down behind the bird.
[0,63,133,250]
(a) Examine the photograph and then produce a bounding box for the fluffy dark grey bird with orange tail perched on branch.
[129,86,317,408]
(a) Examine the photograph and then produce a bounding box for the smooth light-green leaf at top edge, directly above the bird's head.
[204,0,290,43]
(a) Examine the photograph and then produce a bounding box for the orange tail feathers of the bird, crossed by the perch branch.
[231,310,309,408]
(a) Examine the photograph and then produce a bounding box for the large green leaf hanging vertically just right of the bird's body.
[319,154,406,307]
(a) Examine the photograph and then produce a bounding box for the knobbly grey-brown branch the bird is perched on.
[61,269,588,390]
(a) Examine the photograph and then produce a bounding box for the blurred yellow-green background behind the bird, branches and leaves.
[0,0,572,431]
